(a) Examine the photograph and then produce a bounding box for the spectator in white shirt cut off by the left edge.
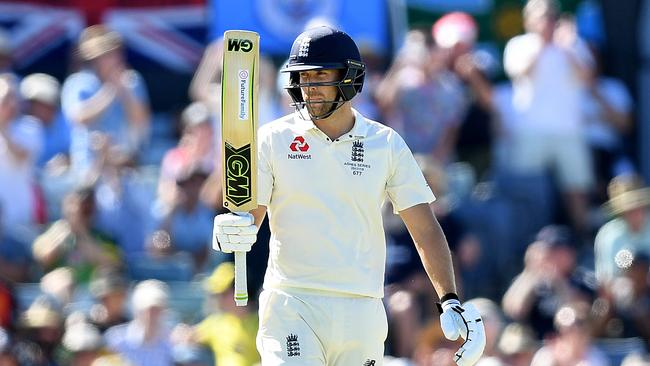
[0,73,43,281]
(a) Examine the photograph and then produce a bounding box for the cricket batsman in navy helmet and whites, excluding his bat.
[213,26,485,366]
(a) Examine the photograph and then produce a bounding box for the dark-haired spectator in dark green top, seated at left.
[32,188,120,283]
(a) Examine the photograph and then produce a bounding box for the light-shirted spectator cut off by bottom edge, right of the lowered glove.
[531,302,609,366]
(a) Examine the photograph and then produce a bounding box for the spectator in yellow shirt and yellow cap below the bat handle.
[180,262,260,366]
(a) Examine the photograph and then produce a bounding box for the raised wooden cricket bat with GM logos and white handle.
[221,30,260,306]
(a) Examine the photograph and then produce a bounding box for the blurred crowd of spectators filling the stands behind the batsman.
[0,0,650,366]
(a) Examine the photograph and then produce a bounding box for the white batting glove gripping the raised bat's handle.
[212,213,257,253]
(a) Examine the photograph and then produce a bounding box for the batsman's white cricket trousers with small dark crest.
[257,290,388,366]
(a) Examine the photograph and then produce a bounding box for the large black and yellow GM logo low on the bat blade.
[225,143,251,206]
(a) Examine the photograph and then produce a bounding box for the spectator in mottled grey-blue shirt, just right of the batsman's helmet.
[377,31,467,163]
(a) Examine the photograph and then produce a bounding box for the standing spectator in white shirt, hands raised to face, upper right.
[503,0,593,238]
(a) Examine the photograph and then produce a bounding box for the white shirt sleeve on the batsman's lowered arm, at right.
[386,133,436,213]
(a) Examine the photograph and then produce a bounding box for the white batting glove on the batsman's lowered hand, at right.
[438,294,485,366]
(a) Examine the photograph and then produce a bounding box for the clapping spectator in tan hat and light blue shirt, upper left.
[61,24,150,173]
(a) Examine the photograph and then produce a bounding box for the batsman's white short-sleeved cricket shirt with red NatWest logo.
[258,111,435,298]
